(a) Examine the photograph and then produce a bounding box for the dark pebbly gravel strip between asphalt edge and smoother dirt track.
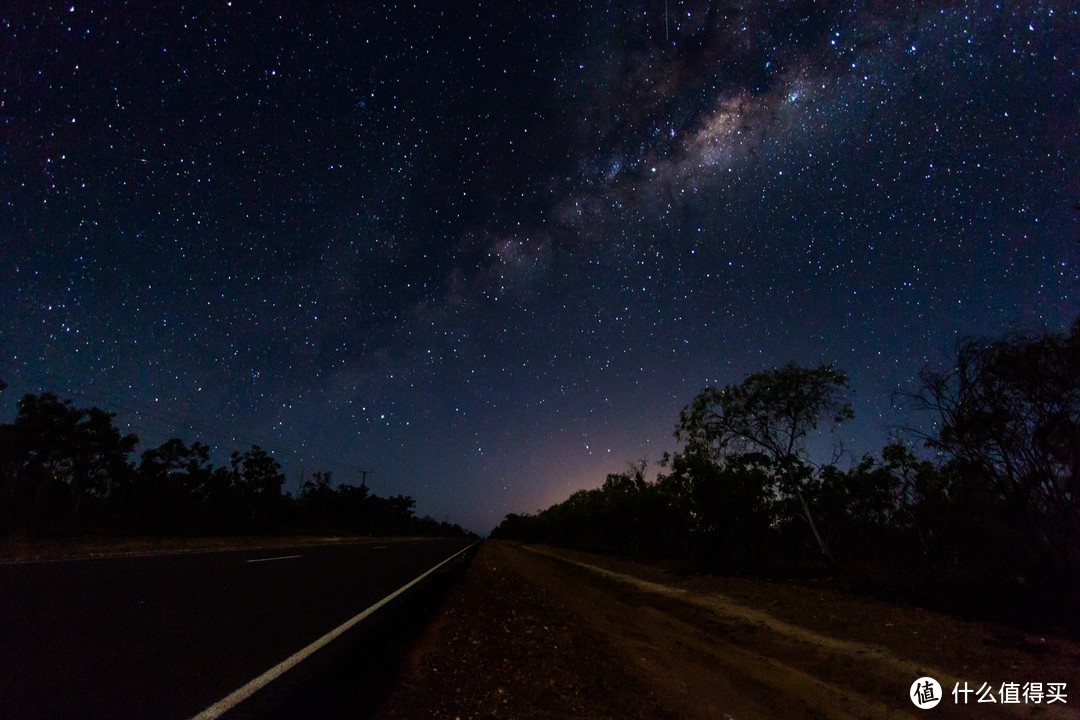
[377,543,677,720]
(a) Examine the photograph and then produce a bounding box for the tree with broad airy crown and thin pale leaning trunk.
[675,364,854,567]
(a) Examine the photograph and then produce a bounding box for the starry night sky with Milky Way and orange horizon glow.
[0,0,1080,532]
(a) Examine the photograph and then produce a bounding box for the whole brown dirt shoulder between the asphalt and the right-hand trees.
[379,542,1080,720]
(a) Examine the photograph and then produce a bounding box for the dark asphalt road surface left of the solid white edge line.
[0,540,469,720]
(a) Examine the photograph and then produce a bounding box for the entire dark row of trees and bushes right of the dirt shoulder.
[492,318,1080,625]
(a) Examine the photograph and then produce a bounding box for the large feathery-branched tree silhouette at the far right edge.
[910,317,1080,576]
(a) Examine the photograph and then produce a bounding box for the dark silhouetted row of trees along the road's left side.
[0,383,465,538]
